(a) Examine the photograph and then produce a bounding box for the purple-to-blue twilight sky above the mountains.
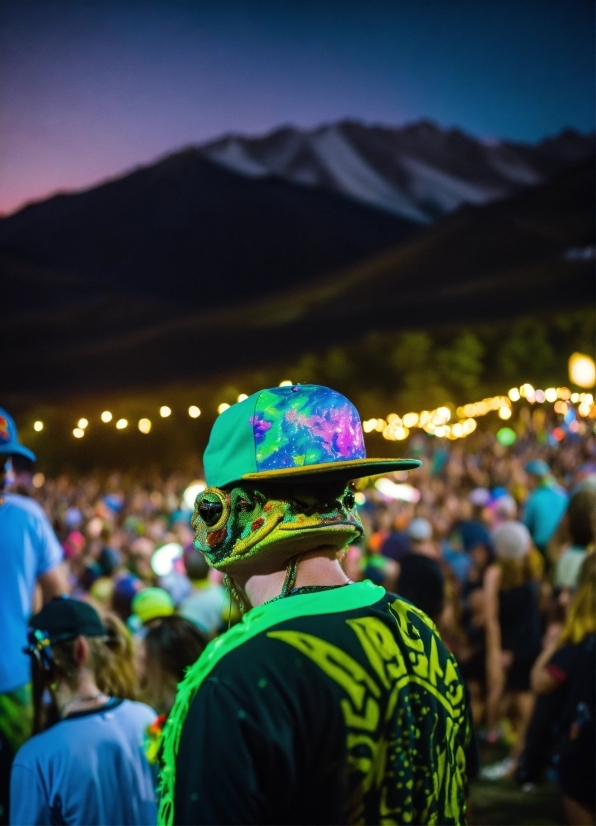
[0,0,594,213]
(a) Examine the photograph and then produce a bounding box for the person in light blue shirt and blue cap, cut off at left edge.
[0,409,68,824]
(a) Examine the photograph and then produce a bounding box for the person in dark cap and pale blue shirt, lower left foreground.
[10,597,157,826]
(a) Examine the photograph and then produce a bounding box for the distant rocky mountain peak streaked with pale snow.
[199,120,594,223]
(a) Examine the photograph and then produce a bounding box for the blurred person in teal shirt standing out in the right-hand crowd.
[523,459,567,555]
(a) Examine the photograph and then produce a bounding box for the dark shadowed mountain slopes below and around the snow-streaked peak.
[0,124,594,399]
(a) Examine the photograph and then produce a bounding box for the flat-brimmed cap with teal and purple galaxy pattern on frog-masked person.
[203,384,420,488]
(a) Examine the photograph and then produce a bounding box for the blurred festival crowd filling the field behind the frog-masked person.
[0,402,596,824]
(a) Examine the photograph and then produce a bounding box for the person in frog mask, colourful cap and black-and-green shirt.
[159,385,470,826]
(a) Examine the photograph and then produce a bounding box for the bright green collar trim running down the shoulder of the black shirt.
[158,580,386,826]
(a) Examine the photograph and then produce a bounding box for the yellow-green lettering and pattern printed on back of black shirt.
[268,600,469,824]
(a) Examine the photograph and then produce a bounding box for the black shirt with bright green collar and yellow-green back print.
[160,582,471,824]
